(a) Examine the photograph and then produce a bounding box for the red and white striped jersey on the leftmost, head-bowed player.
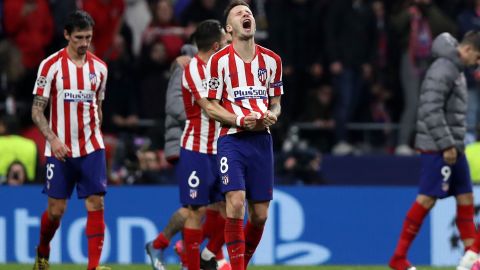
[33,48,107,157]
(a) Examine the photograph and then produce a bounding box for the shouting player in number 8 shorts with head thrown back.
[203,1,283,270]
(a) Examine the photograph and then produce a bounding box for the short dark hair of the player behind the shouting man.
[193,20,223,52]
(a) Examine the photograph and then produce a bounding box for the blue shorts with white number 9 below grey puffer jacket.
[418,153,472,199]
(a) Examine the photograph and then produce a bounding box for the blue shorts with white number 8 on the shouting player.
[217,131,273,201]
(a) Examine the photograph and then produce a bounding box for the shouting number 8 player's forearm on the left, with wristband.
[196,98,257,130]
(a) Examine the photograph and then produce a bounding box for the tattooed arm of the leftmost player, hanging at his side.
[32,95,70,161]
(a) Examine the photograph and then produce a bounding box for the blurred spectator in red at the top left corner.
[4,0,54,102]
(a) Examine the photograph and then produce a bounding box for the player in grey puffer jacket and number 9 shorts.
[389,32,480,270]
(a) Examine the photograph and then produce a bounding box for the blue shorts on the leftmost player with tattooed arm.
[43,149,107,199]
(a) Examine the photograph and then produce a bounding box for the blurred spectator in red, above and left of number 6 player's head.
[142,0,185,64]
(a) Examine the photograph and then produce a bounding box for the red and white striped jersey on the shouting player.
[207,44,283,136]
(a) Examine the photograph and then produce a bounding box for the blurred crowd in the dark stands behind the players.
[0,0,480,185]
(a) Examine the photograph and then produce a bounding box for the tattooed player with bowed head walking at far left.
[32,10,110,270]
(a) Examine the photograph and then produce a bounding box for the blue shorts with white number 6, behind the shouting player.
[175,148,224,206]
